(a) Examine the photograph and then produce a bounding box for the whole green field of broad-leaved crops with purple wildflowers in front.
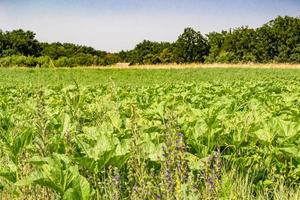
[0,68,300,200]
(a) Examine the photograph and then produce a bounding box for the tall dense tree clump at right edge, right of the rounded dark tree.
[206,16,300,63]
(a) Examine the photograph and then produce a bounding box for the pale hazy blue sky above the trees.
[0,0,300,52]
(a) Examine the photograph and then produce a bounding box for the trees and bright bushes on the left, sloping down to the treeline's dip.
[0,29,120,67]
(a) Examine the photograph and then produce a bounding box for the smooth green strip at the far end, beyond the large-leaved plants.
[0,68,300,86]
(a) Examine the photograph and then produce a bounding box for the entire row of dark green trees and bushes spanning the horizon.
[0,16,300,67]
